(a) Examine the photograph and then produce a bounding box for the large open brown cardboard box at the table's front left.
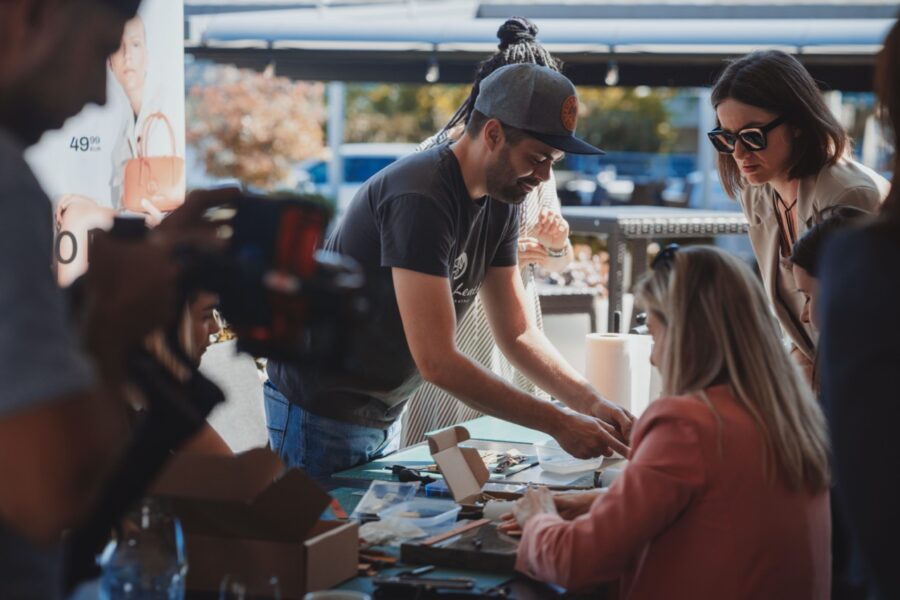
[151,448,359,600]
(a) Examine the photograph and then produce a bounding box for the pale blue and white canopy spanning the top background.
[185,0,894,91]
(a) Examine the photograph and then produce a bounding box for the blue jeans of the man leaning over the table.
[263,381,400,483]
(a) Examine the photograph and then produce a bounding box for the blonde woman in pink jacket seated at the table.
[508,247,831,600]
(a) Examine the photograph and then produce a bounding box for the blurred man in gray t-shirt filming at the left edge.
[0,0,220,599]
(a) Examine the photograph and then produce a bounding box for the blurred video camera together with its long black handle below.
[65,194,370,590]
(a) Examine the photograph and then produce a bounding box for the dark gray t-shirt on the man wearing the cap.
[268,144,519,428]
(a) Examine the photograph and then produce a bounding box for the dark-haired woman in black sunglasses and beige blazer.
[708,50,888,378]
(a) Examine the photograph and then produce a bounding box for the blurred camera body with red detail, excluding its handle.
[185,195,369,370]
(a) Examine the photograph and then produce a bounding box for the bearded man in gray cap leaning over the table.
[264,64,633,479]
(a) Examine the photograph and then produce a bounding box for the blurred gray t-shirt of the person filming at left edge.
[0,130,93,599]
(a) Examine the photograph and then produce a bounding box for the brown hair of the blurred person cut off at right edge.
[875,20,900,218]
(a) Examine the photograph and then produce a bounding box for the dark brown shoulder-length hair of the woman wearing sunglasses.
[712,50,849,198]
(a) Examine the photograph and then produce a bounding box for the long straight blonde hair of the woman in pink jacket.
[636,246,829,491]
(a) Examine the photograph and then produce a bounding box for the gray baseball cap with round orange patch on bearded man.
[475,64,605,154]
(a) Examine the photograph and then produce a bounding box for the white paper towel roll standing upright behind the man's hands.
[584,333,655,416]
